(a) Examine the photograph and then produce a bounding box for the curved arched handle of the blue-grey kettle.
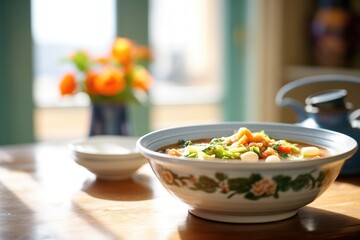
[275,74,360,122]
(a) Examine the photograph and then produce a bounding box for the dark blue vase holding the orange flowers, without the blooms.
[89,102,129,136]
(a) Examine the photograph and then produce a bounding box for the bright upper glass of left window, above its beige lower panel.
[31,0,116,107]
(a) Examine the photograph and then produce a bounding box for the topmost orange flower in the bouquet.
[112,37,134,64]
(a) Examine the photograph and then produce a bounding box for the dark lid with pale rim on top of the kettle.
[305,89,350,112]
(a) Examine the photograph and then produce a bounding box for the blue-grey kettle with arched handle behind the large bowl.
[275,74,360,175]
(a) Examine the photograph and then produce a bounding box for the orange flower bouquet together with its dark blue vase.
[60,37,153,135]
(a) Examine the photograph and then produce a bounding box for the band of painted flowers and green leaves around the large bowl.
[157,166,326,200]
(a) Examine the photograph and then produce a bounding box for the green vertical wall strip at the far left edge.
[0,0,34,145]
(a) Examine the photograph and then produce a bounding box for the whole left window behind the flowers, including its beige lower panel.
[31,0,116,141]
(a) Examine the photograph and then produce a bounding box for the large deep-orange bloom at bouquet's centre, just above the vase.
[94,67,126,96]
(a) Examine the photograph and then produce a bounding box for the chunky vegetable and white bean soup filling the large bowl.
[159,127,330,162]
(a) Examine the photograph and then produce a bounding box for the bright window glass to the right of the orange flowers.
[150,0,222,105]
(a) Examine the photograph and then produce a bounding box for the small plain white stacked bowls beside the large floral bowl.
[70,136,147,180]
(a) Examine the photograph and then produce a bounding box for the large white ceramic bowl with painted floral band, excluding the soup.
[137,122,357,223]
